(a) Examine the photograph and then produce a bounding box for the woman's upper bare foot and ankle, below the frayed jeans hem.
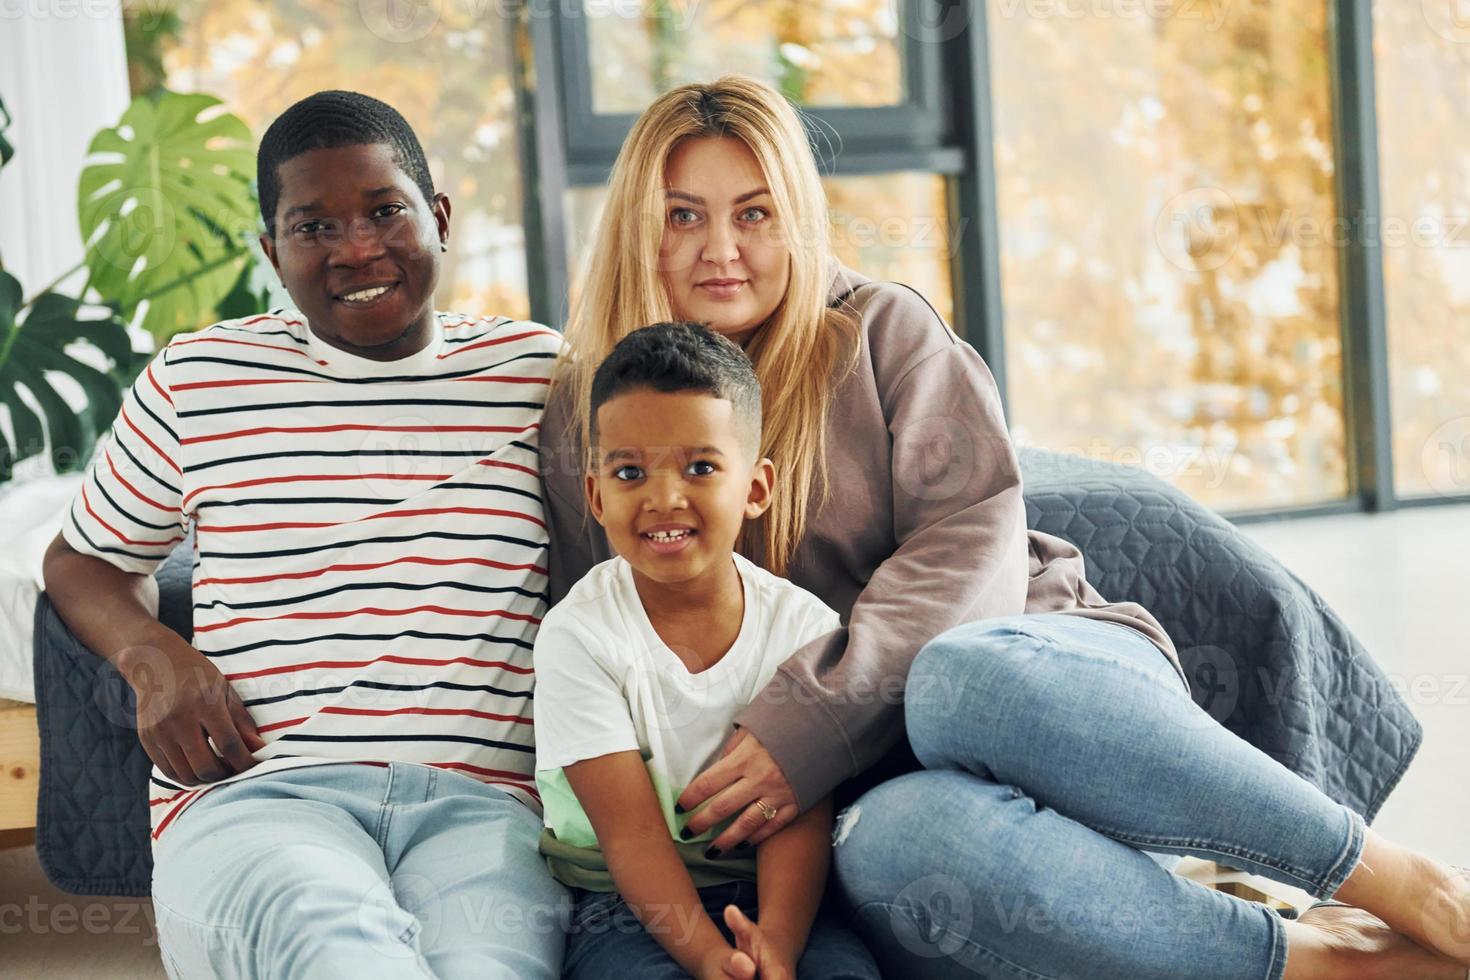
[1333,830,1470,968]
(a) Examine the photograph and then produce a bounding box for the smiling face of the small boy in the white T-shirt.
[587,388,773,598]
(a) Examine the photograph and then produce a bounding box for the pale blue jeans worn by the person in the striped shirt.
[153,764,570,980]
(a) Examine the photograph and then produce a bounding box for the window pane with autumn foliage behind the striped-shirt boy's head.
[129,0,529,316]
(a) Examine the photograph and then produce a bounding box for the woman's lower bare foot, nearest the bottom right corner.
[1282,907,1466,980]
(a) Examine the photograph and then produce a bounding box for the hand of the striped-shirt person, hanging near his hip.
[113,633,266,786]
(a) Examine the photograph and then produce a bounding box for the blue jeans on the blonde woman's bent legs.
[833,614,1364,980]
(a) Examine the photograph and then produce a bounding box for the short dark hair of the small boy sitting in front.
[589,320,760,460]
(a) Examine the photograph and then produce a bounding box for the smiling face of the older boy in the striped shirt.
[260,143,450,360]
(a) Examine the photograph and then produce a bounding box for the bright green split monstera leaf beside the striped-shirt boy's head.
[78,91,259,339]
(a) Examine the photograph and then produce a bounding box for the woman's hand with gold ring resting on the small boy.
[678,729,800,854]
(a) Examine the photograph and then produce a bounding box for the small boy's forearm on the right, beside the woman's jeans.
[756,796,832,973]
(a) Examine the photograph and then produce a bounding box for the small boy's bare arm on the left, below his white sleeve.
[563,751,754,980]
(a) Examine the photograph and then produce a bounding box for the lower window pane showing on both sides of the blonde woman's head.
[566,173,954,320]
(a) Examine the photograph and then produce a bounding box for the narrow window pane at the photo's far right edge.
[1373,0,1470,497]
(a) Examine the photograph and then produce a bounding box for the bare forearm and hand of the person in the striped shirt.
[41,535,265,786]
